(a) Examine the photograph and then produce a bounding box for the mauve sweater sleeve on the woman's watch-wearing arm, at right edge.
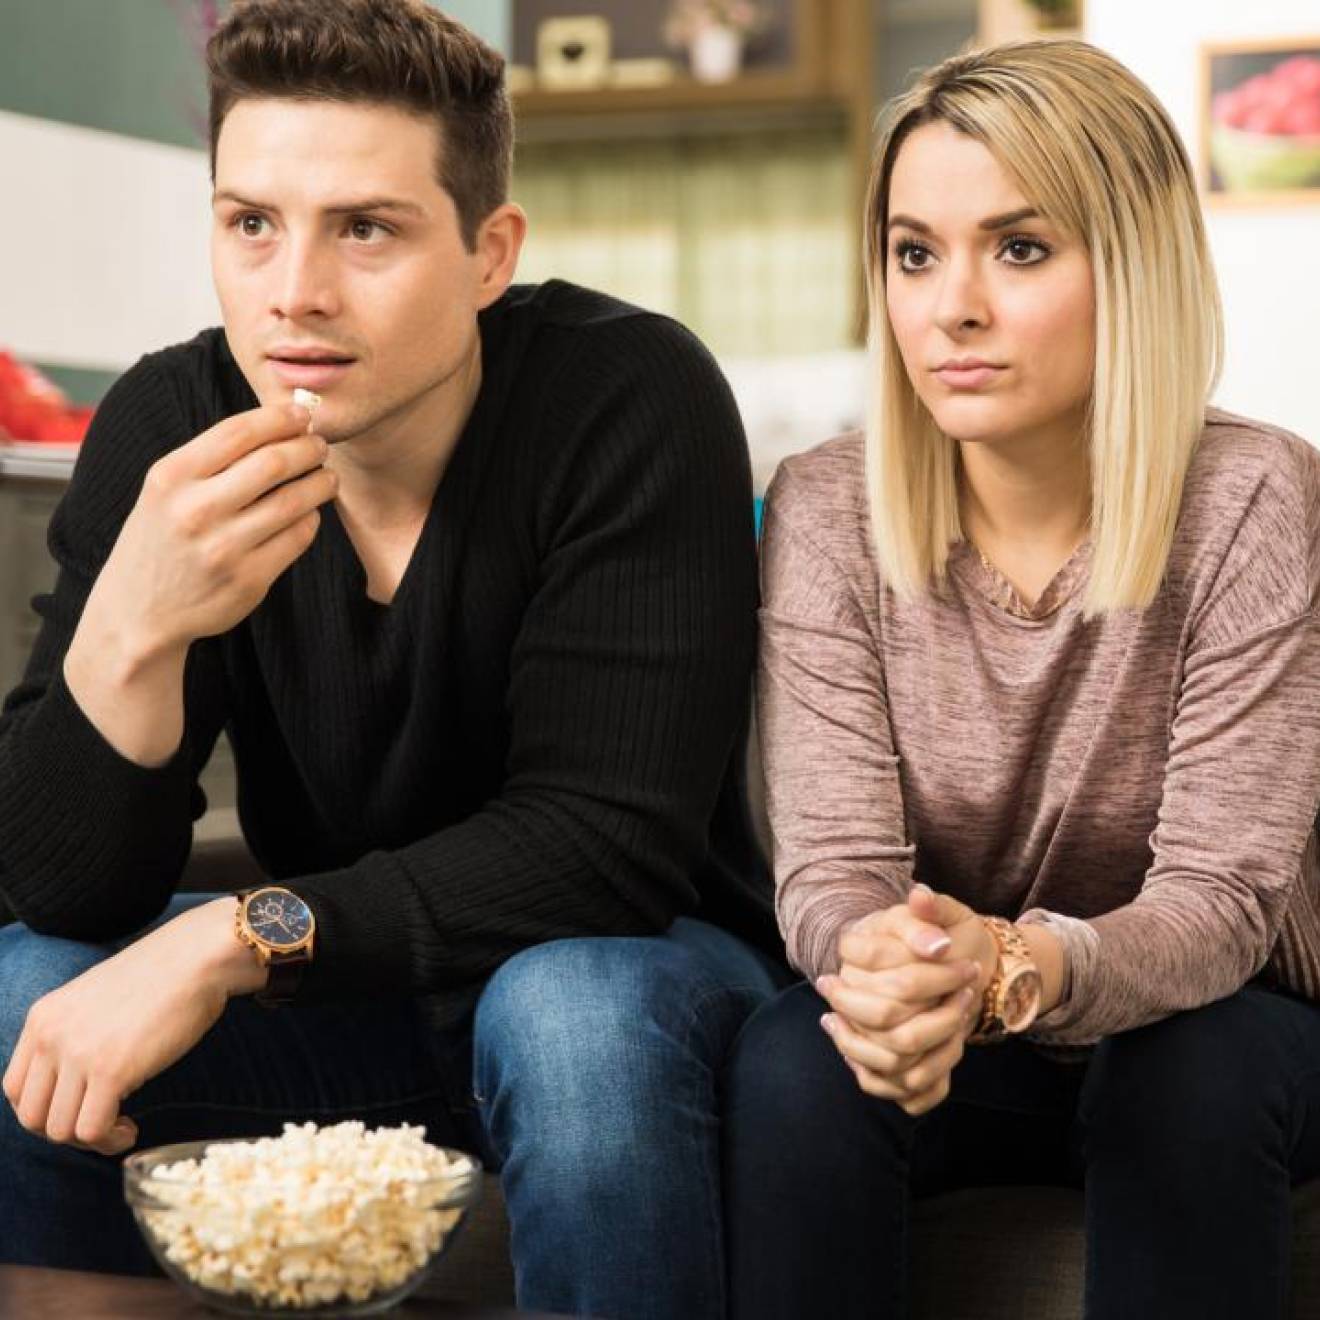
[1023,440,1320,1045]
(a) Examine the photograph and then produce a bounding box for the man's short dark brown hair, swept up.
[206,0,513,251]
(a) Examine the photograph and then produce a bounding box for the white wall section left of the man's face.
[0,111,220,371]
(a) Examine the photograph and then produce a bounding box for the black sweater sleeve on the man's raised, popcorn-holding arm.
[0,359,223,941]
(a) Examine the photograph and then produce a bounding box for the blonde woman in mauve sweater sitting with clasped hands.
[727,41,1320,1320]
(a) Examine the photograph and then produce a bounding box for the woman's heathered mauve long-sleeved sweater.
[759,409,1320,1045]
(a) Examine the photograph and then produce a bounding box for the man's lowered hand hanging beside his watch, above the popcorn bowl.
[3,898,267,1155]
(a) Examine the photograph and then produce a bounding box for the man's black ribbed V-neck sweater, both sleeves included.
[0,281,777,1011]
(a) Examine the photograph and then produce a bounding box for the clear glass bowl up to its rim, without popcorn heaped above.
[123,1138,482,1316]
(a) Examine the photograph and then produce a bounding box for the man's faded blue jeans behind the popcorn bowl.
[0,894,779,1320]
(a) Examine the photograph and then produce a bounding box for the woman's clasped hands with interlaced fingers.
[817,884,998,1114]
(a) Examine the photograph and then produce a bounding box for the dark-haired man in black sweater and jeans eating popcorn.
[0,0,776,1317]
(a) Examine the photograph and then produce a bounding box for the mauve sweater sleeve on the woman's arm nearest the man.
[758,469,915,979]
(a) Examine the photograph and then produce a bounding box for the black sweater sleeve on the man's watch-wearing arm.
[288,317,755,1002]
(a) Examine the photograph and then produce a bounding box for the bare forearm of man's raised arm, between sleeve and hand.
[63,591,187,770]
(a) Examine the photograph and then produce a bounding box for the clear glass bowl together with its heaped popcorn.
[124,1122,482,1316]
